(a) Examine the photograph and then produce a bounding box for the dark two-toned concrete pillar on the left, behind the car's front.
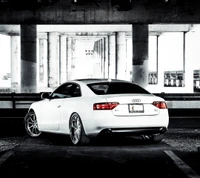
[20,24,37,93]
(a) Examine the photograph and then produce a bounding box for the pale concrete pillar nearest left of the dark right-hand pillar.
[116,32,126,80]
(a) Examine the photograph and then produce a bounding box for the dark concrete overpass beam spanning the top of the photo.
[0,0,200,24]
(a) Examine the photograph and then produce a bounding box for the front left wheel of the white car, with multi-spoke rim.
[24,110,41,137]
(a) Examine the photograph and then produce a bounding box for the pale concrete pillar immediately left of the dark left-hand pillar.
[11,36,21,93]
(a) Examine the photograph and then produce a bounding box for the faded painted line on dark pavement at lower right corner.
[164,150,200,178]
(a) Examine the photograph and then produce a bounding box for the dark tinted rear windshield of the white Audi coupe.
[88,82,150,95]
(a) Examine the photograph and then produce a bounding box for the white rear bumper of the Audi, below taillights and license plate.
[84,112,169,136]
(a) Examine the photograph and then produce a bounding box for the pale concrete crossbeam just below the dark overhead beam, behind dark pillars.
[0,24,199,36]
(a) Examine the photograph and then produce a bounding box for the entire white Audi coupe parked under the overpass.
[24,79,169,145]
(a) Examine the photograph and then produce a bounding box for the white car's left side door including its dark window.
[41,83,72,131]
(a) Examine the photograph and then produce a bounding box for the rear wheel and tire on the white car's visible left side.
[69,113,90,145]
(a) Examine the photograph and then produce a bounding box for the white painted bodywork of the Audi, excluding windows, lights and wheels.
[29,79,169,135]
